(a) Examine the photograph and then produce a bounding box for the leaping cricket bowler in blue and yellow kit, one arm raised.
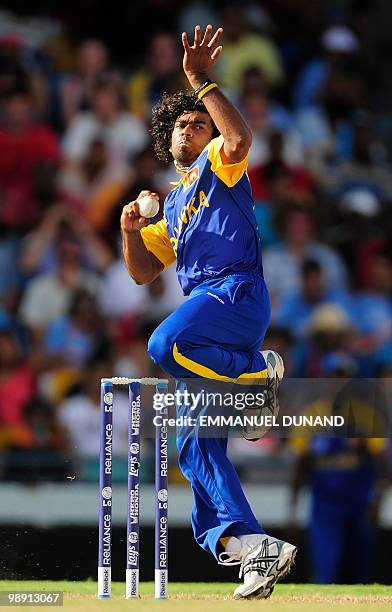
[121,25,297,599]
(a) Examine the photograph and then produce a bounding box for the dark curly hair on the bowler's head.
[150,91,219,164]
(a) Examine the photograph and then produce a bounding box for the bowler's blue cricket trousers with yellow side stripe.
[148,274,270,557]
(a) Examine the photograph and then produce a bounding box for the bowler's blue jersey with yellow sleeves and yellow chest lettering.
[141,136,263,295]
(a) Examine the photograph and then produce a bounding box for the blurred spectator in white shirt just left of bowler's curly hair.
[63,79,147,164]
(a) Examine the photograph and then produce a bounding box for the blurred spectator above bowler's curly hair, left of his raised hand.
[127,32,186,121]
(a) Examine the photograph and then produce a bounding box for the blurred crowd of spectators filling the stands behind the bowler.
[0,0,392,512]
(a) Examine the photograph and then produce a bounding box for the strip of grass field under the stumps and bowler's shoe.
[0,581,392,612]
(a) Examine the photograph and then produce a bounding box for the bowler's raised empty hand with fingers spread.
[182,25,223,89]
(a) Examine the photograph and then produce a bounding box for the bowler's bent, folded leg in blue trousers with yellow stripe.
[148,274,270,384]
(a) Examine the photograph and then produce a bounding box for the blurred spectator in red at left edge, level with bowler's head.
[0,84,60,232]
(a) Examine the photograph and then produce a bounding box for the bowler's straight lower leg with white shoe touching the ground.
[177,414,297,599]
